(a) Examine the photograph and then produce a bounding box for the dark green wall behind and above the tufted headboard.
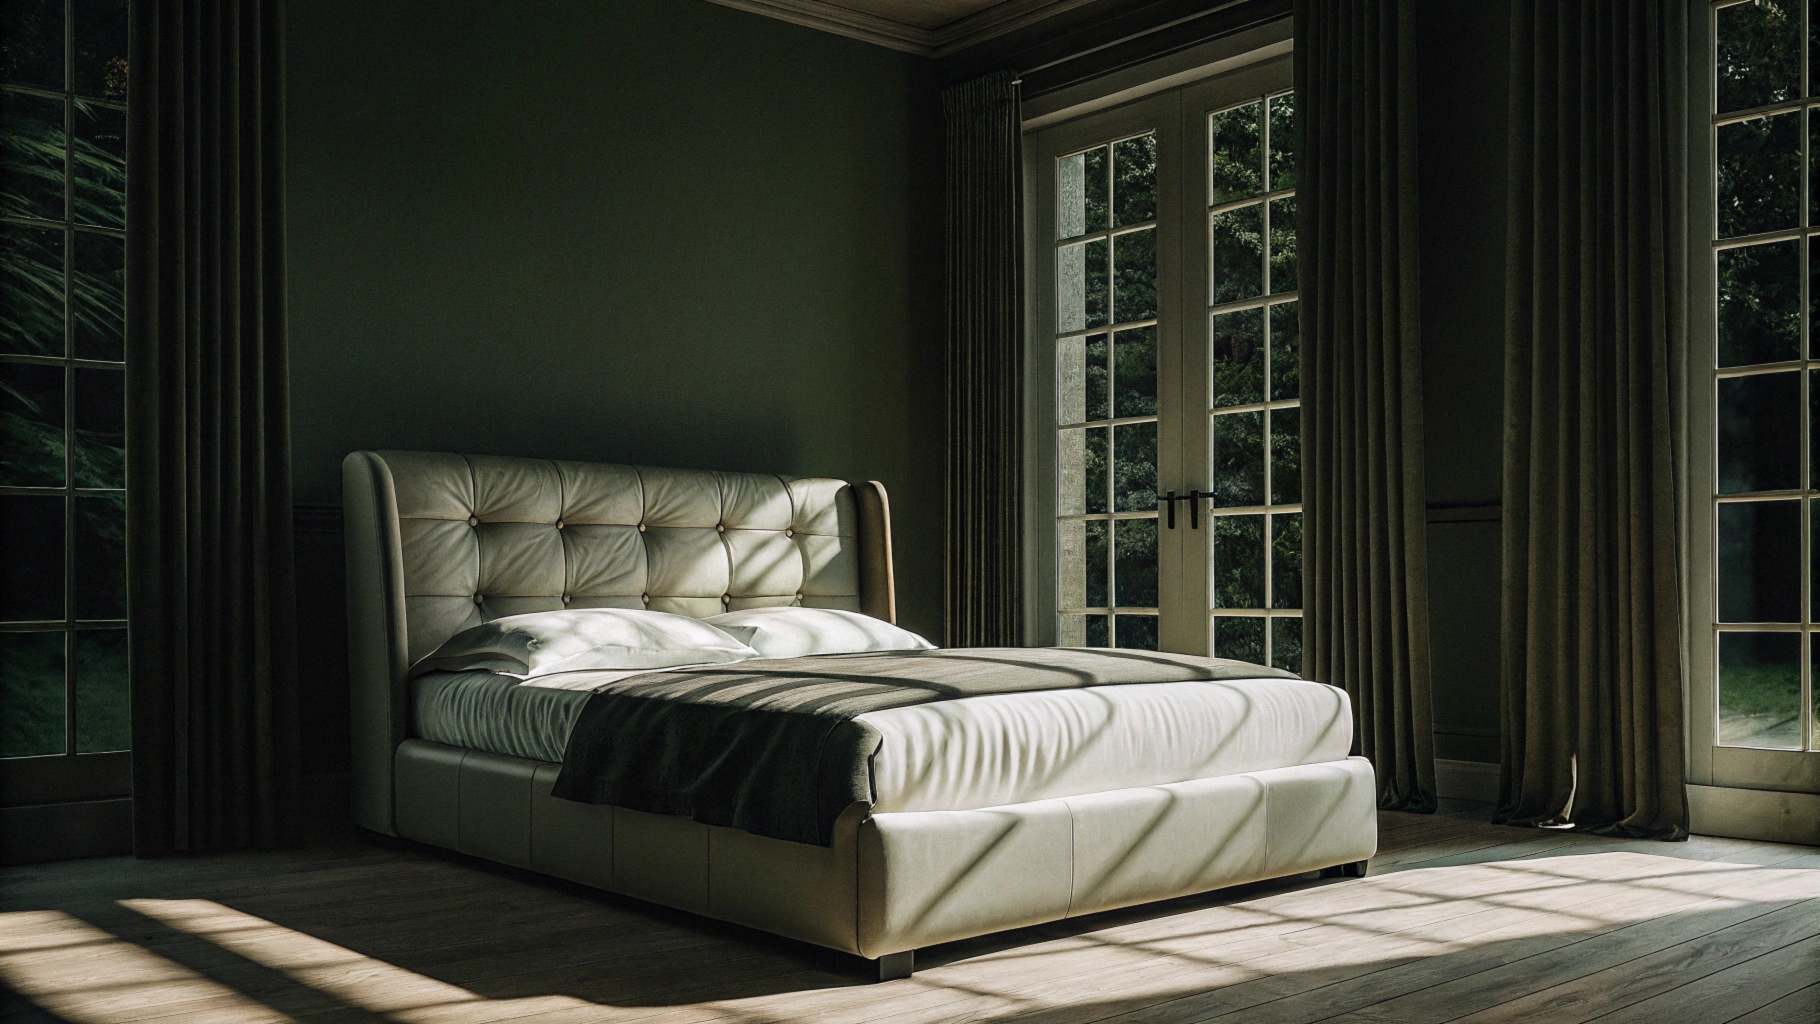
[286,0,943,771]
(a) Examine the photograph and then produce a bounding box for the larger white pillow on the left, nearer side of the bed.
[411,607,759,678]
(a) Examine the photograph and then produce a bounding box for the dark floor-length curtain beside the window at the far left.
[126,0,298,857]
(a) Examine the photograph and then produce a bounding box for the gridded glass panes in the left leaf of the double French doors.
[1056,133,1158,651]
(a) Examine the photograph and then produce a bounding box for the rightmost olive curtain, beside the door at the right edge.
[1498,0,1689,838]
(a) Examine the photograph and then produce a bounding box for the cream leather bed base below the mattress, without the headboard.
[393,738,1378,959]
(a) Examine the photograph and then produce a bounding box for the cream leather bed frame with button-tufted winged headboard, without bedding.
[342,451,1378,979]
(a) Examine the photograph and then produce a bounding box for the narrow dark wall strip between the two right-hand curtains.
[1416,0,1511,760]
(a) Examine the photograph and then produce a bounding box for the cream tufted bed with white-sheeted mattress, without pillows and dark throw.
[344,451,1378,979]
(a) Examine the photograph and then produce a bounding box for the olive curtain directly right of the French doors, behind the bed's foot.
[1296,0,1434,811]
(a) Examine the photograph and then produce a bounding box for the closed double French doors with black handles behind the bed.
[1026,56,1301,669]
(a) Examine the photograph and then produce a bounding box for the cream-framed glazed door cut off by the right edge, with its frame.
[1689,0,1820,800]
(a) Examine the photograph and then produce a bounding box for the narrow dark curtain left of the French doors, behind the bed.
[941,71,1025,648]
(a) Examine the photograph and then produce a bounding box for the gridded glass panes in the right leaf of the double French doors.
[1205,93,1301,671]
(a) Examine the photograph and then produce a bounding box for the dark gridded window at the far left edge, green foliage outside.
[0,0,129,771]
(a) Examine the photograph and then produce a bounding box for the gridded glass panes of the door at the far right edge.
[1702,0,1820,749]
